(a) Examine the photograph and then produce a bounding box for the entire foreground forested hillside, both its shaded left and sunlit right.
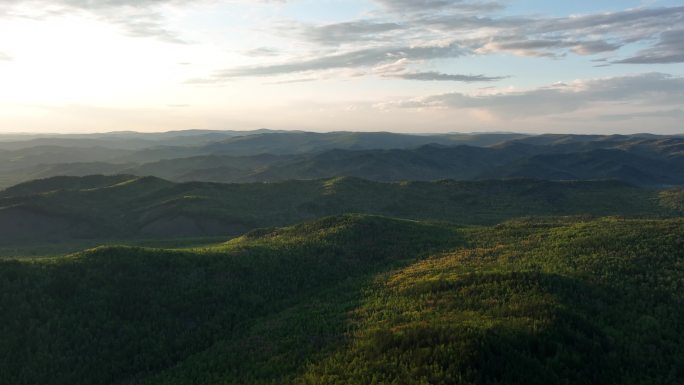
[0,215,684,385]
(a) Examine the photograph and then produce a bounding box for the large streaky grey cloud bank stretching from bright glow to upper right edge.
[211,0,684,82]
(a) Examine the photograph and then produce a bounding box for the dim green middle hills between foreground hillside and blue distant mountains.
[0,175,678,243]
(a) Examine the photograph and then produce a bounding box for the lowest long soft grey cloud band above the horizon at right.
[381,73,684,118]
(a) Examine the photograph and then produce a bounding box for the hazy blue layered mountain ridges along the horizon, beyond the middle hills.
[0,131,684,187]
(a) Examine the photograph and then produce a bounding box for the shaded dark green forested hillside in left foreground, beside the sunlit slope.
[0,216,459,385]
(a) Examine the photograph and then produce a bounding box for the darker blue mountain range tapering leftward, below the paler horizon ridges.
[115,139,684,186]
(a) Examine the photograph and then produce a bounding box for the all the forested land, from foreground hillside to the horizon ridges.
[0,131,684,385]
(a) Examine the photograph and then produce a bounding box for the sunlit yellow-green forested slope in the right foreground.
[296,219,684,384]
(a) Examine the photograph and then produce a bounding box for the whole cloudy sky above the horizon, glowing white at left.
[0,0,684,134]
